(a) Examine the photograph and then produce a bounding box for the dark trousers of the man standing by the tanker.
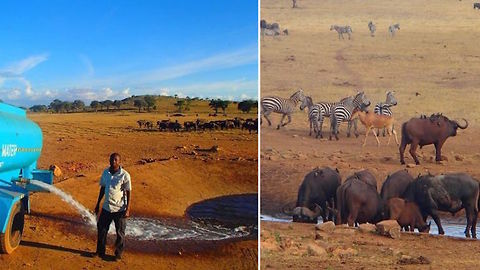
[97,209,126,256]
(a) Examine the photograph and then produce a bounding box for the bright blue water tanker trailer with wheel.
[0,103,53,253]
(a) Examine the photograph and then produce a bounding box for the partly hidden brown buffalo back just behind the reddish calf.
[380,169,414,201]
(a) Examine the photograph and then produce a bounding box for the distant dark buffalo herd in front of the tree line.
[137,117,258,133]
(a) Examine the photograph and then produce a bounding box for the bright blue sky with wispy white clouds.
[0,0,258,107]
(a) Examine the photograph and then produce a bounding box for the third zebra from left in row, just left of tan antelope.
[329,91,370,141]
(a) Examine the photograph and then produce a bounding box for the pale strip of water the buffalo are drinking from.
[260,214,480,238]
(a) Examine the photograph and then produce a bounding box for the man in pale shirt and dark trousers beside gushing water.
[95,153,132,260]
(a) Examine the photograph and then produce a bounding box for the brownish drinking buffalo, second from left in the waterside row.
[329,174,385,226]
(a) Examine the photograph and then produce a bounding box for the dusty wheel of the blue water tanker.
[0,201,25,254]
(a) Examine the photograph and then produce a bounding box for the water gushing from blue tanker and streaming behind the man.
[30,180,250,240]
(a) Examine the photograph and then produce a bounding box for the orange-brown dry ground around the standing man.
[0,112,258,269]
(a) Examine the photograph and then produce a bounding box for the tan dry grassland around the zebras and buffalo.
[260,0,480,269]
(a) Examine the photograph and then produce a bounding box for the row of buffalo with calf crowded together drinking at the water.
[284,167,479,238]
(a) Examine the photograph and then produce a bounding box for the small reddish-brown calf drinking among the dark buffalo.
[387,198,431,233]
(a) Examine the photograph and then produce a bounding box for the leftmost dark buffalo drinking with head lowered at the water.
[285,167,342,223]
